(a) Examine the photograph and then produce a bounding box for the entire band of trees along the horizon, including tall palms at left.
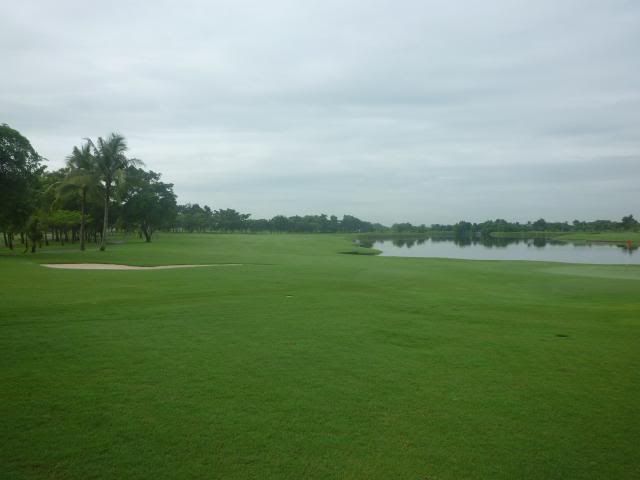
[0,124,639,252]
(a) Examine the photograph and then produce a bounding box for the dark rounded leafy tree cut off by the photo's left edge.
[0,123,44,248]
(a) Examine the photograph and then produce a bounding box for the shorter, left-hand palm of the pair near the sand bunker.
[59,139,99,250]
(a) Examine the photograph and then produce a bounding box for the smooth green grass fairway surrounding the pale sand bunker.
[0,234,640,480]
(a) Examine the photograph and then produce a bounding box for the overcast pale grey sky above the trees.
[0,0,640,225]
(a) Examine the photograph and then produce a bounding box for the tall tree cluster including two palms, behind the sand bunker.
[0,124,177,252]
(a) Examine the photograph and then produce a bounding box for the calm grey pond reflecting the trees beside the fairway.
[372,238,640,265]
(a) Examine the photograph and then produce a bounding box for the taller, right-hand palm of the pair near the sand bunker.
[91,133,142,250]
